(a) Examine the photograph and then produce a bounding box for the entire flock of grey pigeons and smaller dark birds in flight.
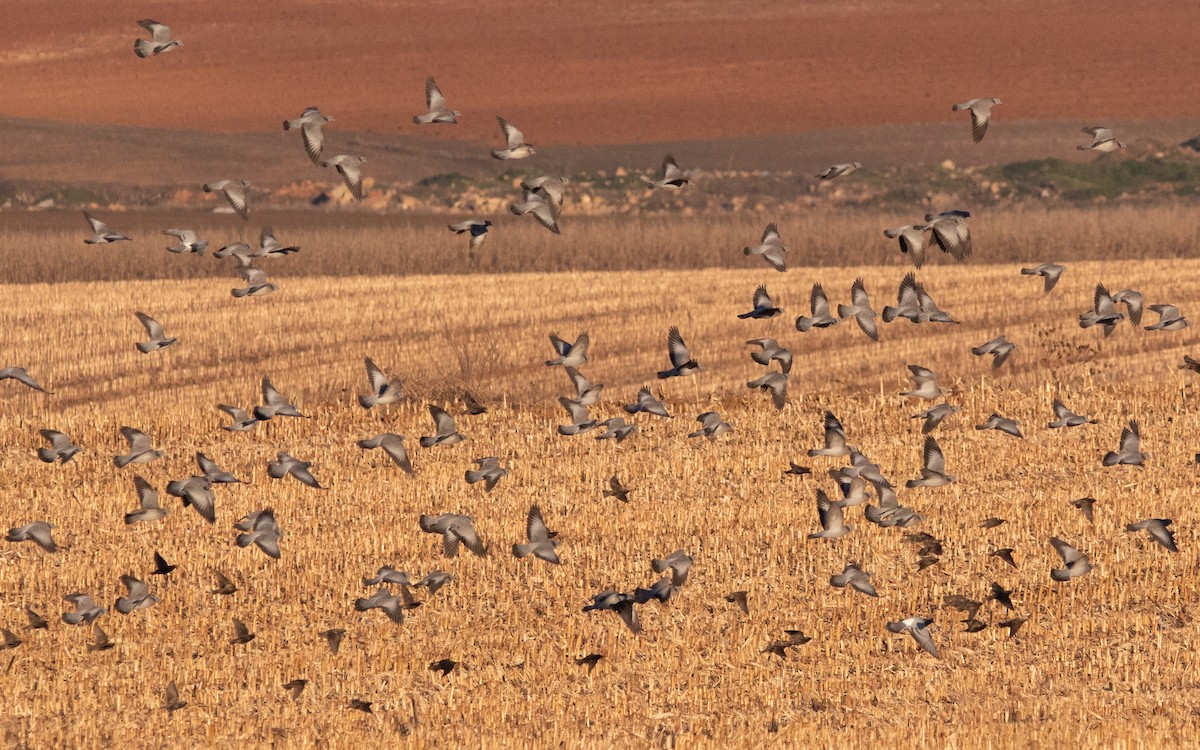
[0,14,1185,712]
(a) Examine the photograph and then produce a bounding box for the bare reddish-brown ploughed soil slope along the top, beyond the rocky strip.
[0,0,1200,144]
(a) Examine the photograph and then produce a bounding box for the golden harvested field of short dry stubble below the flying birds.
[0,255,1200,748]
